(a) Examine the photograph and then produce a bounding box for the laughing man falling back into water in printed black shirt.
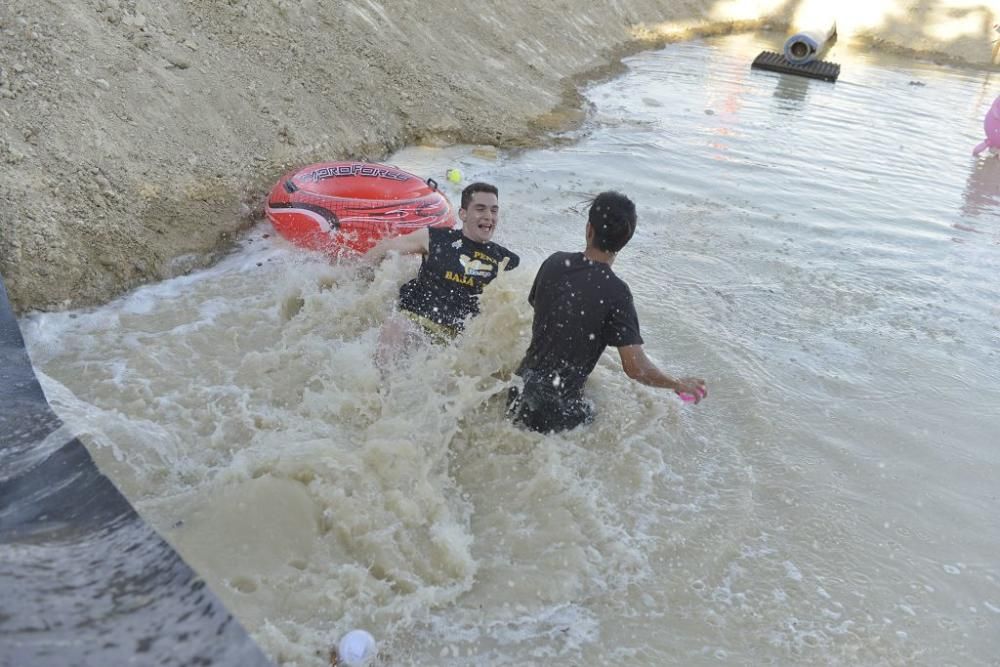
[365,183,520,368]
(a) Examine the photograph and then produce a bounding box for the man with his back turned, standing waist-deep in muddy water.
[508,192,708,433]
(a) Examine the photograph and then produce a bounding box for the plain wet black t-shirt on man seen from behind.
[517,252,642,398]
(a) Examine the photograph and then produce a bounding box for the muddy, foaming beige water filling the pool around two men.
[22,36,1000,666]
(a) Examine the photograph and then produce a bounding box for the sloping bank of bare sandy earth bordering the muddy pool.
[0,0,998,312]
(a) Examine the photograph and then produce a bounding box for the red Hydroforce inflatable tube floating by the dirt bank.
[264,162,455,255]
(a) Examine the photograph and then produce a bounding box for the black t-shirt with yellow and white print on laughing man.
[399,227,520,328]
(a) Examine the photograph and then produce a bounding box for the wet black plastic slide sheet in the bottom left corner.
[0,278,272,667]
